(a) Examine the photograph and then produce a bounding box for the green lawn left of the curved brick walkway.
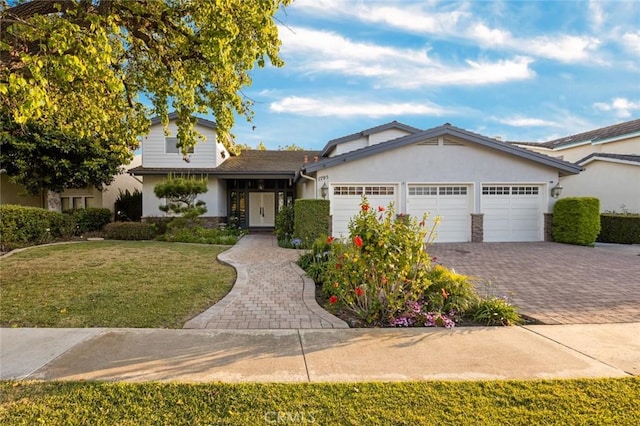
[0,241,235,328]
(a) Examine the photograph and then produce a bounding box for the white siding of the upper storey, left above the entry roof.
[142,122,228,168]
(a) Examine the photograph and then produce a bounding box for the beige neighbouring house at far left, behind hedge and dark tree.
[0,155,142,216]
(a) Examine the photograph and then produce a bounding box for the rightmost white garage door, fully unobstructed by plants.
[481,185,542,242]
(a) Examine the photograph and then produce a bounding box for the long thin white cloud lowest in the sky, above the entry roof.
[269,96,450,117]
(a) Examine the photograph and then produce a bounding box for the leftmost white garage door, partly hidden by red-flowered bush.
[331,185,398,237]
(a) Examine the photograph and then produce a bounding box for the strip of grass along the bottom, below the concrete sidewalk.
[0,378,640,425]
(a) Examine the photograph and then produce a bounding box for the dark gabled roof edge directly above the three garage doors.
[304,123,582,174]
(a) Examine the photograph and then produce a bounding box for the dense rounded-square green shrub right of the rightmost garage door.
[553,197,600,246]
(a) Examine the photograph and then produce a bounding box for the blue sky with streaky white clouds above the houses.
[228,0,640,149]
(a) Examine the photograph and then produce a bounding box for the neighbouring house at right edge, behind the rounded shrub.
[511,119,640,213]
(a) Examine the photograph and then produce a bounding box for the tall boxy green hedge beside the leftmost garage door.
[293,199,329,247]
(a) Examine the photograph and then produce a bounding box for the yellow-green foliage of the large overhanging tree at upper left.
[0,0,290,154]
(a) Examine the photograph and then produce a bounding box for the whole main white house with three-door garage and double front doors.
[130,119,580,242]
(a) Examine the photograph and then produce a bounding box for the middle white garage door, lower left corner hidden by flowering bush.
[407,184,472,243]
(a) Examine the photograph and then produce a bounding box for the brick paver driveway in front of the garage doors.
[429,243,640,324]
